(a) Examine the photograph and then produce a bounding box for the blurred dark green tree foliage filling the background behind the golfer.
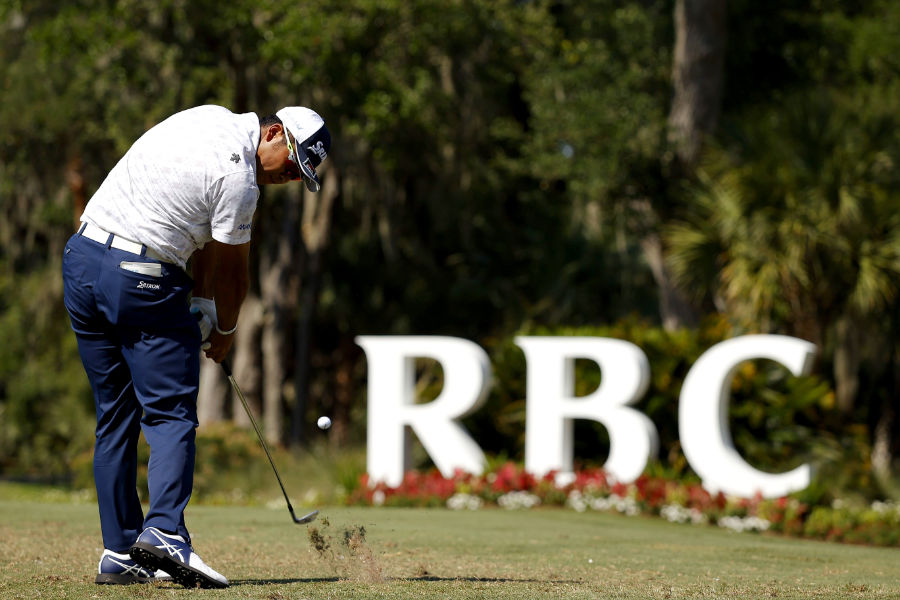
[0,0,900,496]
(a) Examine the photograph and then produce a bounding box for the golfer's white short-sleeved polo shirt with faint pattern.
[81,105,260,268]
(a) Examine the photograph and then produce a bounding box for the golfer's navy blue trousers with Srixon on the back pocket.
[63,234,200,552]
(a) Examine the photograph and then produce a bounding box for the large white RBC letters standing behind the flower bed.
[356,335,815,498]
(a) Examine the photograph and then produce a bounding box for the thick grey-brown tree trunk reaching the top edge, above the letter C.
[669,0,727,173]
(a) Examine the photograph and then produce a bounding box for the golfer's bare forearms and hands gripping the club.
[191,240,250,362]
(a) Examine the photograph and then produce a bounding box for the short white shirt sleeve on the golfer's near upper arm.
[209,173,259,245]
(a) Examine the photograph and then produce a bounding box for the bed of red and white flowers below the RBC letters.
[347,463,900,546]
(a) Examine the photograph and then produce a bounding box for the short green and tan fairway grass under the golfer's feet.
[0,500,900,600]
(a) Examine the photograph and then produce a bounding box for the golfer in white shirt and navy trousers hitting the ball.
[62,106,331,587]
